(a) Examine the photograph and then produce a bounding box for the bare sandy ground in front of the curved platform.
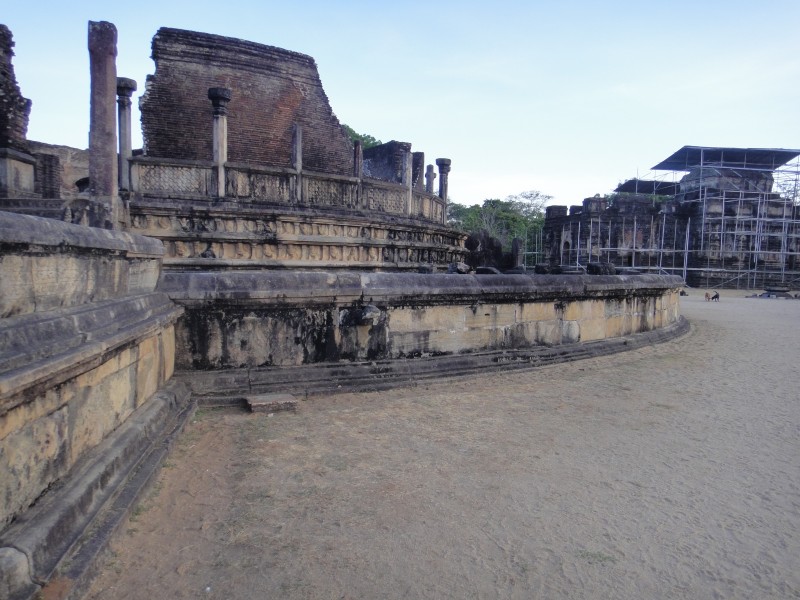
[83,291,800,600]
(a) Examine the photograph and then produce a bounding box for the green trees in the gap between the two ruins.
[447,190,552,251]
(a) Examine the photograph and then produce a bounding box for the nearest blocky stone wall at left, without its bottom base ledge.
[0,212,181,526]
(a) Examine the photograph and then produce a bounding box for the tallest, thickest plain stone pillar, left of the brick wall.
[88,21,125,229]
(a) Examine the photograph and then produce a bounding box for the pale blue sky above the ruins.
[0,0,800,205]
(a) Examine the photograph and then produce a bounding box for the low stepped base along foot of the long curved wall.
[180,317,689,405]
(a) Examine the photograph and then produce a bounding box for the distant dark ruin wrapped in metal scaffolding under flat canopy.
[551,146,800,290]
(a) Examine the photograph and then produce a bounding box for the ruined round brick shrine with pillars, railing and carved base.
[129,28,466,270]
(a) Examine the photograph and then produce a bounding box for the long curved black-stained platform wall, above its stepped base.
[160,272,682,369]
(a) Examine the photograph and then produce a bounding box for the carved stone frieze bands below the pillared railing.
[131,195,466,270]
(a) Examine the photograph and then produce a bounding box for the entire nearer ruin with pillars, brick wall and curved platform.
[0,23,688,600]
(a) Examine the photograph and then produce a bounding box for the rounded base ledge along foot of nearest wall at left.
[0,382,194,600]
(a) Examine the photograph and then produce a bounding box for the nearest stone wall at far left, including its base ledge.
[0,212,185,598]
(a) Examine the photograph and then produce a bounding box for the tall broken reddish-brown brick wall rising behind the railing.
[140,28,353,175]
